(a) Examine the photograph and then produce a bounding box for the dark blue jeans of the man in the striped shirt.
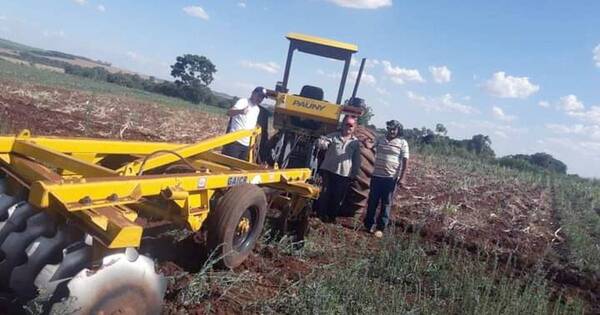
[364,176,396,231]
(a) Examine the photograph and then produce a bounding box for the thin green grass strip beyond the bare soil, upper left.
[0,59,225,114]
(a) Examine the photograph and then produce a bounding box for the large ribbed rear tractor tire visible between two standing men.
[340,126,375,217]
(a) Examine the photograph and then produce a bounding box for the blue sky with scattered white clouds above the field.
[0,0,600,177]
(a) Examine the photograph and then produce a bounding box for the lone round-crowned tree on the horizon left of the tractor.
[171,54,217,87]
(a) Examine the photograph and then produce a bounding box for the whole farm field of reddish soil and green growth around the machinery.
[0,60,600,314]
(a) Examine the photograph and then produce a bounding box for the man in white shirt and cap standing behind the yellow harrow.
[222,86,267,160]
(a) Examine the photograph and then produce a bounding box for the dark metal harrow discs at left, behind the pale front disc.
[0,202,92,312]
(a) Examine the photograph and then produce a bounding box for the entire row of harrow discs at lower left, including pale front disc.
[0,179,165,314]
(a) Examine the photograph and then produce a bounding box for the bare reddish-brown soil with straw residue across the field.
[0,81,600,314]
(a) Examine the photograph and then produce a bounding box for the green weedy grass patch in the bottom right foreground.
[257,233,584,314]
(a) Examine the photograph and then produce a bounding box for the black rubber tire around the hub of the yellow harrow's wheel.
[207,184,267,269]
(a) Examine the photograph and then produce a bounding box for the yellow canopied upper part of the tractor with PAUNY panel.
[273,33,364,137]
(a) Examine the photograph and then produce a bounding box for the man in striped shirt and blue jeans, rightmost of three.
[364,120,408,238]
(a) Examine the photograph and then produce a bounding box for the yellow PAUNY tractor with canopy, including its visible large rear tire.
[265,33,374,216]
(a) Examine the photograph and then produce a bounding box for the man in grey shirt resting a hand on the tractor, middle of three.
[317,116,360,222]
